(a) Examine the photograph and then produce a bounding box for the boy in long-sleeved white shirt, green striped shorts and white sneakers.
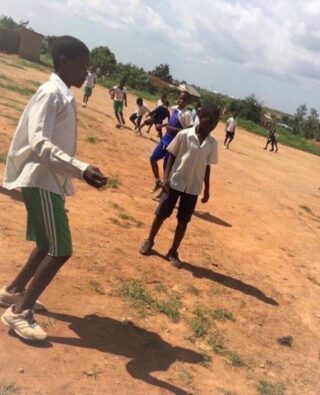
[0,36,107,341]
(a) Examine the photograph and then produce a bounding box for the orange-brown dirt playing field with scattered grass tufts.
[0,55,320,395]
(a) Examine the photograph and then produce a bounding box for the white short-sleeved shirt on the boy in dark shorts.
[167,127,218,195]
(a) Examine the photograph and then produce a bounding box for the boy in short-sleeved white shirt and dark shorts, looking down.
[139,104,220,268]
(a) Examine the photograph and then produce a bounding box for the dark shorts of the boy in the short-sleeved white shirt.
[155,188,198,224]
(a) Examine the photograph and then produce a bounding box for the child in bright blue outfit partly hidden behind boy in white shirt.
[150,91,193,192]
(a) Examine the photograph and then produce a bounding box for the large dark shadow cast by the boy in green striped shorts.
[41,311,203,395]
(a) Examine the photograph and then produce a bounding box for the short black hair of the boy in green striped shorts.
[51,36,90,71]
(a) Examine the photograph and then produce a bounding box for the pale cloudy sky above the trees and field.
[0,0,320,112]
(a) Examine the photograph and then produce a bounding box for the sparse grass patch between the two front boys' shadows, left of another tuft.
[119,280,182,322]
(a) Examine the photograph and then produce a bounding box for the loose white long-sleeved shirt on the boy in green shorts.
[3,74,88,197]
